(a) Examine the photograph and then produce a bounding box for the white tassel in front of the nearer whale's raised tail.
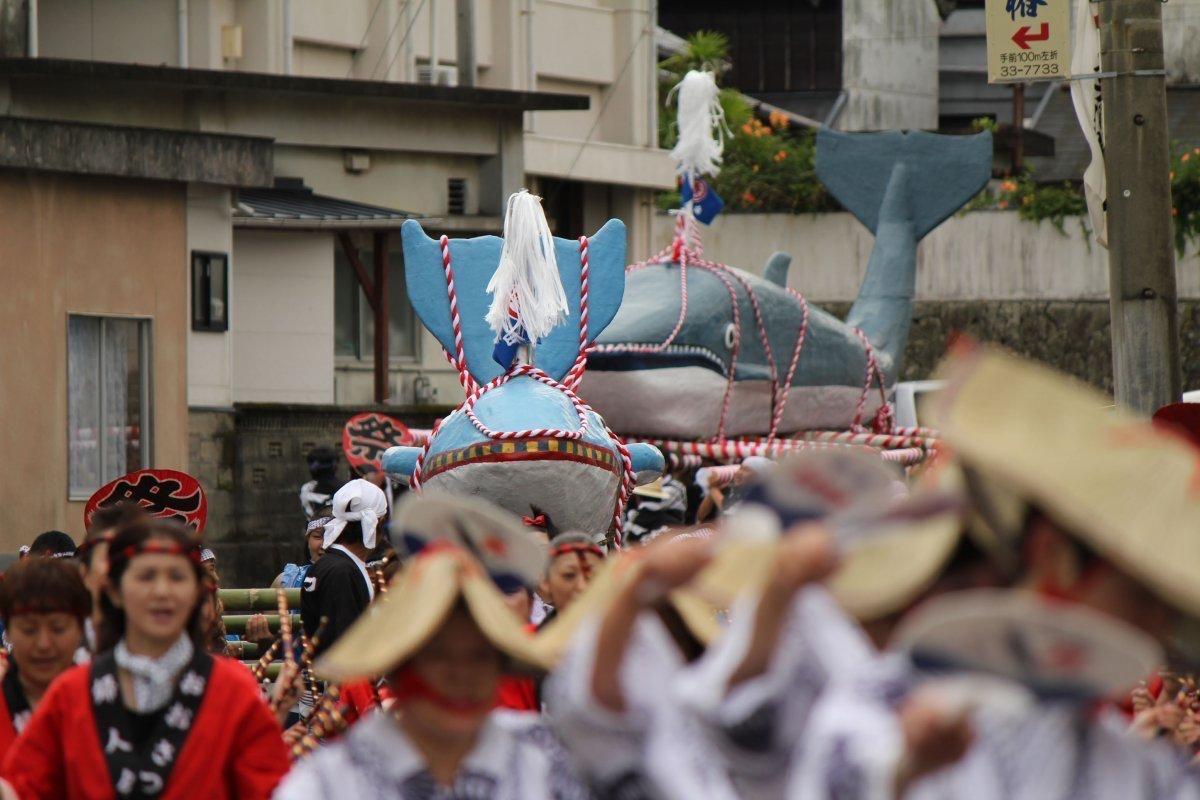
[486,190,570,344]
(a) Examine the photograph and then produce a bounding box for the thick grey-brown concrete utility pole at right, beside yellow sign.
[1094,0,1180,414]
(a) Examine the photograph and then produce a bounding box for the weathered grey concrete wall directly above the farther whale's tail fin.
[836,0,940,131]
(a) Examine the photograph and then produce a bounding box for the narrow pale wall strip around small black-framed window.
[184,184,236,407]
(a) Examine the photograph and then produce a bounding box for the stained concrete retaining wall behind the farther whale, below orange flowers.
[638,211,1200,391]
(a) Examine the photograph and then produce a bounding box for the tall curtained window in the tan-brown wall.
[67,314,151,500]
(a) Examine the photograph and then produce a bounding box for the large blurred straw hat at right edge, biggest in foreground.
[926,347,1200,614]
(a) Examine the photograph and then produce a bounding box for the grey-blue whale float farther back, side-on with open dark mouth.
[581,130,992,440]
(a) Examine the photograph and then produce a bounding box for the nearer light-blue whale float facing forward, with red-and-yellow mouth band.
[383,219,664,535]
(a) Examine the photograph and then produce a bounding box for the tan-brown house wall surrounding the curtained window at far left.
[0,173,187,551]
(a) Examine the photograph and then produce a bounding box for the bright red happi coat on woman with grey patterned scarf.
[0,657,290,800]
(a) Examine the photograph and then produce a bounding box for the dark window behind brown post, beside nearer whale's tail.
[334,247,419,361]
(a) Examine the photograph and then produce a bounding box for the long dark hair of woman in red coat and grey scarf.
[96,517,210,651]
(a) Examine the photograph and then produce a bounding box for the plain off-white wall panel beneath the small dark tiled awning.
[230,229,334,403]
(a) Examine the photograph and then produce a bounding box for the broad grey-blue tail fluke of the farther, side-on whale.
[816,128,992,241]
